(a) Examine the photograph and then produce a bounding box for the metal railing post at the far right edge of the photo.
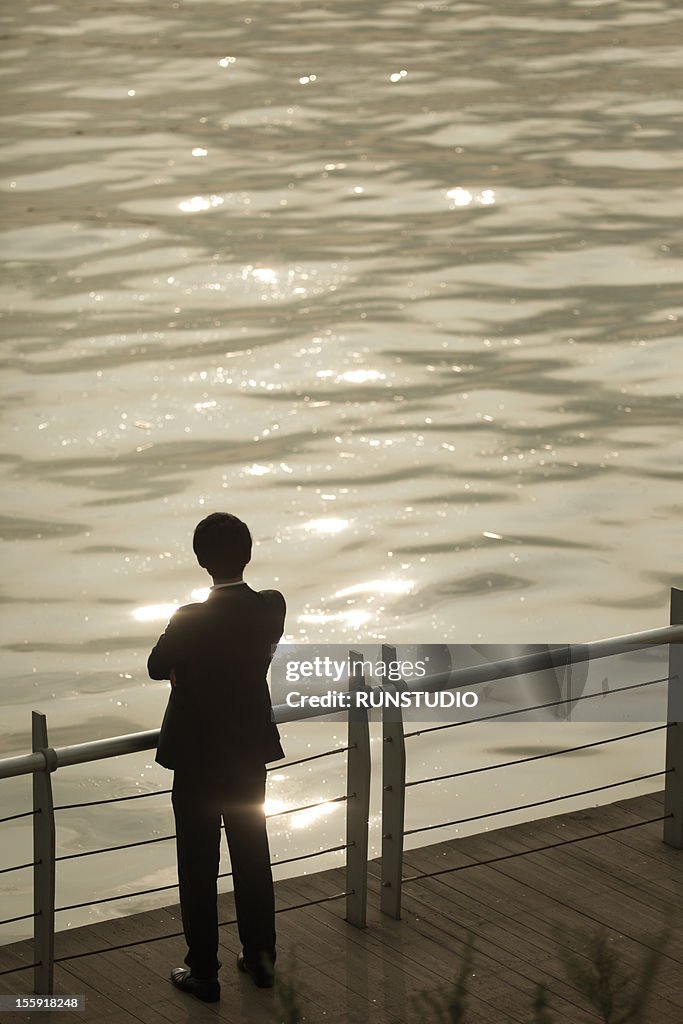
[663,587,683,850]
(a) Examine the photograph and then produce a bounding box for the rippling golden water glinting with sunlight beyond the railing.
[0,0,683,937]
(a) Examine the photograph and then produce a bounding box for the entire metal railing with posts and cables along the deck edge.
[0,590,683,994]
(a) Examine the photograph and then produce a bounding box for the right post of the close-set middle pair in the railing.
[380,644,405,921]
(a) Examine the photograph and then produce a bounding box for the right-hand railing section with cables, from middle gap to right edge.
[380,589,683,919]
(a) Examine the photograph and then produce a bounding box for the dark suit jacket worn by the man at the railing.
[147,584,286,780]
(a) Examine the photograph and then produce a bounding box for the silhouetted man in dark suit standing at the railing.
[147,512,286,1002]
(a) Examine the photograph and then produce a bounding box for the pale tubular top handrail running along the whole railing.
[0,625,683,779]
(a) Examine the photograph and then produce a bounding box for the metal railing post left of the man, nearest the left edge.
[31,711,57,995]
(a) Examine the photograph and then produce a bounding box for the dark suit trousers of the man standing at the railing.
[172,764,275,979]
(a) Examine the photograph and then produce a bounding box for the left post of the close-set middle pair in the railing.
[346,650,370,928]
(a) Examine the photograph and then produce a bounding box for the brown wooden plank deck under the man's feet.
[0,794,683,1024]
